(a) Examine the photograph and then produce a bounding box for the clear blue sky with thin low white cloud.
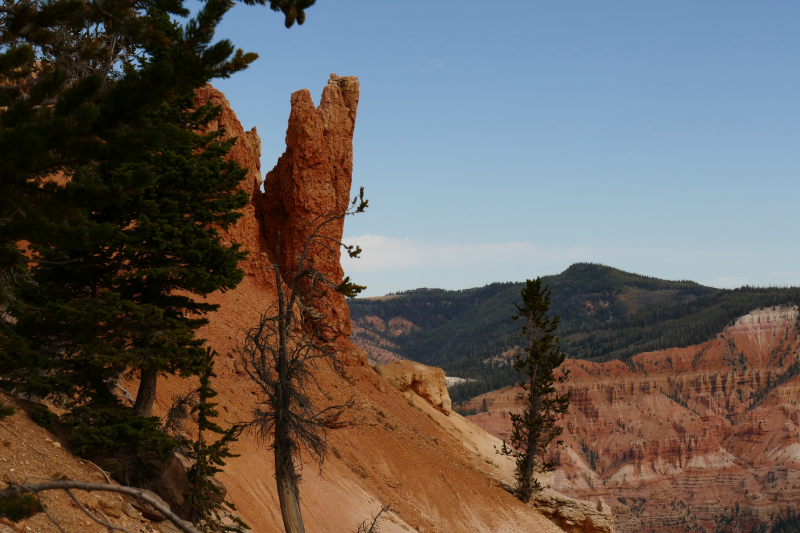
[208,0,800,295]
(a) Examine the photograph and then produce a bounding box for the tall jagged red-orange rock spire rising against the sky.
[254,74,360,347]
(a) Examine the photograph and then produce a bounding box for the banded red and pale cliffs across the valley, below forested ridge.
[469,307,800,532]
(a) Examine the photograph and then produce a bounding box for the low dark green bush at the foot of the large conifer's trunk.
[62,404,181,486]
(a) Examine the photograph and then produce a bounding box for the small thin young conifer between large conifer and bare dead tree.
[186,349,250,532]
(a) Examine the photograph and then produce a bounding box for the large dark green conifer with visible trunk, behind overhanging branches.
[0,76,248,417]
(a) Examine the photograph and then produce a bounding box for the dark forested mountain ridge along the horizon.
[348,263,800,404]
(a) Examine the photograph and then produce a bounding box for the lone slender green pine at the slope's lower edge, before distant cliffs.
[500,278,569,503]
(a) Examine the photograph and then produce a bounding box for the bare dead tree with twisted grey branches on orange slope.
[237,187,367,533]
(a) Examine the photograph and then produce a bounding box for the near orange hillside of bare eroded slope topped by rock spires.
[0,77,607,533]
